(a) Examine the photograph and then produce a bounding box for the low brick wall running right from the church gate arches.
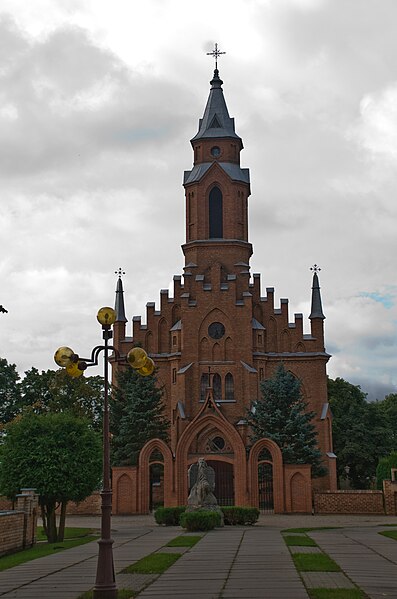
[314,490,385,514]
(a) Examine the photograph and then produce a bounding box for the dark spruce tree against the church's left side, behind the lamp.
[110,368,169,466]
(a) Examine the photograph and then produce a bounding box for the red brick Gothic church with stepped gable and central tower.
[113,65,336,514]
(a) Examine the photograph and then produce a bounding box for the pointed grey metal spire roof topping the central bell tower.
[191,69,241,142]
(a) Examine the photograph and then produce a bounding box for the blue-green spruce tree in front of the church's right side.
[248,364,326,476]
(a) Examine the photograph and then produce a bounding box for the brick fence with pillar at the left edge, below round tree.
[0,489,38,555]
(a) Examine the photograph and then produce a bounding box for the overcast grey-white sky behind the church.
[0,0,397,399]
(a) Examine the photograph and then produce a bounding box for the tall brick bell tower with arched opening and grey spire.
[182,62,252,272]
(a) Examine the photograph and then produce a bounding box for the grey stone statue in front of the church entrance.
[186,458,223,526]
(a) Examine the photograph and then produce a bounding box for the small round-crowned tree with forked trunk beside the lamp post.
[0,413,102,542]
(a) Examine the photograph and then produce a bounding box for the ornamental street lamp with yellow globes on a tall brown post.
[54,307,155,599]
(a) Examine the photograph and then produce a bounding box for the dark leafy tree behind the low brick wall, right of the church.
[328,378,392,489]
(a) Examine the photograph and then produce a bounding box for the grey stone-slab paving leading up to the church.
[0,516,397,599]
